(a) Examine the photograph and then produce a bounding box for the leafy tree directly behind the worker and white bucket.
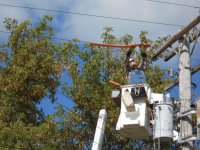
[57,27,170,149]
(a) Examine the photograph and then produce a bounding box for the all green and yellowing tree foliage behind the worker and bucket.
[0,16,170,150]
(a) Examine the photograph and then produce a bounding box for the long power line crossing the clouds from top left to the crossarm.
[0,3,183,27]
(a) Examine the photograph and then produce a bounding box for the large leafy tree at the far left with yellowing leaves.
[0,16,67,149]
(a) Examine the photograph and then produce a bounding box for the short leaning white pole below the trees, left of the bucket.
[92,109,107,150]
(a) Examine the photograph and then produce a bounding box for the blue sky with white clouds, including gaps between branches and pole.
[0,0,200,114]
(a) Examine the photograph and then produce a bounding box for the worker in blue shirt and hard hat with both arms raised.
[125,48,146,85]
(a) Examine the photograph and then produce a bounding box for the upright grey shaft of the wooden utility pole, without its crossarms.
[179,37,193,150]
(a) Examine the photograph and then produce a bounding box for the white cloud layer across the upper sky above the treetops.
[0,0,200,41]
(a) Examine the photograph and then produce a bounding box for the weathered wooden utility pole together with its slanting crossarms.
[152,15,200,150]
